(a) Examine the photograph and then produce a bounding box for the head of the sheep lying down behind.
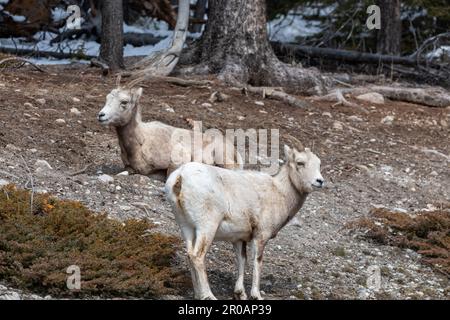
[97,87,142,127]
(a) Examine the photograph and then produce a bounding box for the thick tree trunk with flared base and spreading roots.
[184,0,326,94]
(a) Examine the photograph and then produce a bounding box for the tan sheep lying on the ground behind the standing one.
[98,81,242,175]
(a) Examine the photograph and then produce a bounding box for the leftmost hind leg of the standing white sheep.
[188,229,217,300]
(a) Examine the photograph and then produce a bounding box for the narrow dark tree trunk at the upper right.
[377,0,402,55]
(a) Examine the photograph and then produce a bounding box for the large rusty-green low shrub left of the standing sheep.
[0,185,189,298]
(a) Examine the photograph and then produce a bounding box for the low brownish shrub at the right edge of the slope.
[349,208,450,276]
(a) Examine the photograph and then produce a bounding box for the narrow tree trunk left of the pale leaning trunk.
[100,0,124,71]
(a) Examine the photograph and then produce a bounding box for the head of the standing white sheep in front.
[284,145,324,193]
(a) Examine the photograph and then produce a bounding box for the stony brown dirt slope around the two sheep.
[0,65,450,299]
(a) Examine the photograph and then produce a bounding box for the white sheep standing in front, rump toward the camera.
[166,146,324,299]
